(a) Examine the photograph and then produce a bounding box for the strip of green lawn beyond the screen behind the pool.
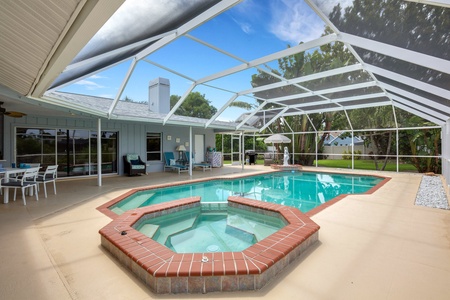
[314,159,417,172]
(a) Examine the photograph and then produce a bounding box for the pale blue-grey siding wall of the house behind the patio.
[2,116,215,174]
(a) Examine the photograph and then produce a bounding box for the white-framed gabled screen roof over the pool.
[46,0,450,130]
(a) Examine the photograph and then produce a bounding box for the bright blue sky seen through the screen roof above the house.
[61,0,324,120]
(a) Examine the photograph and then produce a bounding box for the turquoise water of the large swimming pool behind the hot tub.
[110,172,383,214]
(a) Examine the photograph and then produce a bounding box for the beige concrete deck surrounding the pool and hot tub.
[0,165,450,300]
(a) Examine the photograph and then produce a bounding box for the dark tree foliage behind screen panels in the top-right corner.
[329,0,450,89]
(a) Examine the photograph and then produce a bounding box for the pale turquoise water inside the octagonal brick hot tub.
[136,207,286,253]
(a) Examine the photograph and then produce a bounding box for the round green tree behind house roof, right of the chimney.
[170,92,217,119]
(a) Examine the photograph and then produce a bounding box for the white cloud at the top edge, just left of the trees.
[269,0,325,45]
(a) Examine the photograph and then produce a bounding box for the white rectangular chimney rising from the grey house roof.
[148,77,170,114]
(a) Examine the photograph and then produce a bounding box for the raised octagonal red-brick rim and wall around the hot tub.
[100,197,319,294]
